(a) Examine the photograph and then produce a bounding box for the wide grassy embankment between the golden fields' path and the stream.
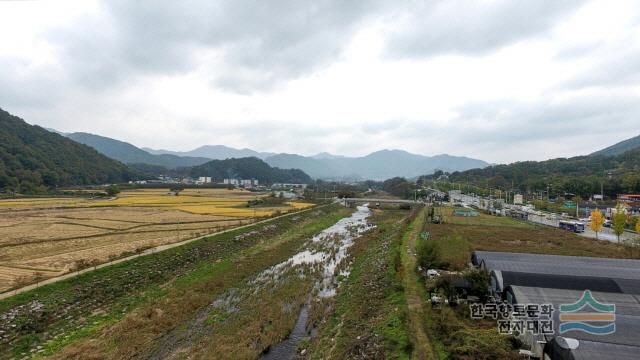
[0,206,350,358]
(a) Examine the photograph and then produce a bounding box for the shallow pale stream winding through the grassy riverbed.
[147,205,373,360]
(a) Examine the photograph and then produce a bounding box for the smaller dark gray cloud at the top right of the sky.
[387,0,584,58]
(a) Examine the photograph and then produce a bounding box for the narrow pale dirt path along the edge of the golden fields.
[0,205,327,300]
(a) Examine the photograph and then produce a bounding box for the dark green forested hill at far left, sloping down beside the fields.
[0,109,133,193]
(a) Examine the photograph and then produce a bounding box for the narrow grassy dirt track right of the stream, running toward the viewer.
[402,210,434,360]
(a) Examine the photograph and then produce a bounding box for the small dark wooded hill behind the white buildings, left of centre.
[178,157,312,184]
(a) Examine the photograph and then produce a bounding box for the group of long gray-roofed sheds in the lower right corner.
[471,251,640,360]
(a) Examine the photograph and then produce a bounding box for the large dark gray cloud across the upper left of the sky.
[52,0,380,93]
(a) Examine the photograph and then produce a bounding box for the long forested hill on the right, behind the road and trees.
[440,148,640,197]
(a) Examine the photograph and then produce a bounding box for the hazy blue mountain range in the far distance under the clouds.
[66,133,489,180]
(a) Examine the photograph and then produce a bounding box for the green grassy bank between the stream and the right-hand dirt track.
[303,210,412,359]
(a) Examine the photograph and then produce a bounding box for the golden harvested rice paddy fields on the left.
[0,189,313,292]
